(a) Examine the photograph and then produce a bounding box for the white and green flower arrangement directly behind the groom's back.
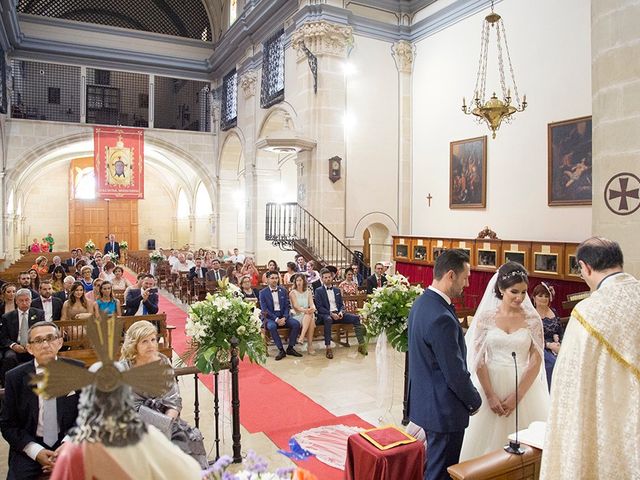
[360,274,424,352]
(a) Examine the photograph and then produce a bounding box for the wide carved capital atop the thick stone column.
[291,21,353,62]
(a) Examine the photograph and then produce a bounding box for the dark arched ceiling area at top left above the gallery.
[17,0,223,41]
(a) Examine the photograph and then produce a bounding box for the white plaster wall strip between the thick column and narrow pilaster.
[348,36,398,242]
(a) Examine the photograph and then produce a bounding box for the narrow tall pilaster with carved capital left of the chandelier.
[391,40,415,235]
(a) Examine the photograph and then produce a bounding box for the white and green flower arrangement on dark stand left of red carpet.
[182,278,267,373]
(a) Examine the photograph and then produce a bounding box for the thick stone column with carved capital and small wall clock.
[291,21,353,240]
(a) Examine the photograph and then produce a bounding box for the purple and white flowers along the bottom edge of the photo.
[202,450,317,480]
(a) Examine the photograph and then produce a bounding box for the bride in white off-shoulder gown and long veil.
[460,262,549,461]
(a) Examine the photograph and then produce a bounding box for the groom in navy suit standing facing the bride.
[409,249,482,480]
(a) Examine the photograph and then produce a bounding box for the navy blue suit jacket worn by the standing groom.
[409,290,482,433]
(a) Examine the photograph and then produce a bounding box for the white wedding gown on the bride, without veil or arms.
[460,327,549,462]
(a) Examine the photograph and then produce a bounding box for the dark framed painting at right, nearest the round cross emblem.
[547,117,593,206]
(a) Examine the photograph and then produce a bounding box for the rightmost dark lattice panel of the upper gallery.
[153,76,211,132]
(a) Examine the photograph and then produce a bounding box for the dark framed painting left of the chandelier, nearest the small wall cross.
[449,135,487,208]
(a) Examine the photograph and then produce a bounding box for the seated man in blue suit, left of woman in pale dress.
[259,271,302,360]
